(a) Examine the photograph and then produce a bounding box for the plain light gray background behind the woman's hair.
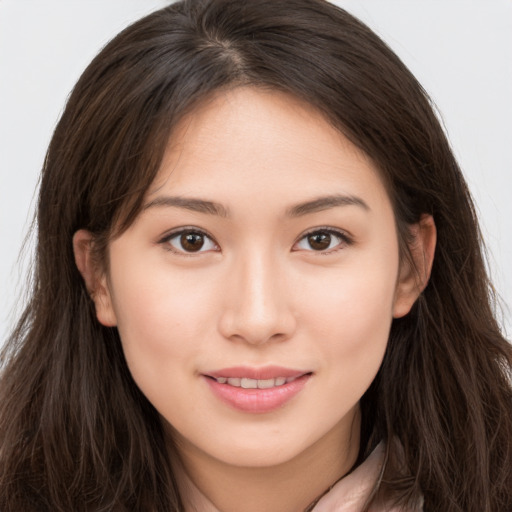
[0,0,512,344]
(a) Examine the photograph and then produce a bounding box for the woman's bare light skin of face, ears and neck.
[74,87,435,512]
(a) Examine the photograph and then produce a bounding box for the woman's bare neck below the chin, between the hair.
[168,410,360,512]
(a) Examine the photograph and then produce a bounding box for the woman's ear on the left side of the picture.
[73,229,117,327]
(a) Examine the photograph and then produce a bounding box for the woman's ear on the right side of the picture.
[393,214,437,318]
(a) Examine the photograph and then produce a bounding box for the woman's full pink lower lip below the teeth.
[205,374,311,414]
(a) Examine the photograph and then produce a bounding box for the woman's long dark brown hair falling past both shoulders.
[0,0,512,512]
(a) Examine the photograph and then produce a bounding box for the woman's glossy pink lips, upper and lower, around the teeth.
[204,366,311,414]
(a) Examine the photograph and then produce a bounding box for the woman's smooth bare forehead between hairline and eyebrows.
[148,87,387,215]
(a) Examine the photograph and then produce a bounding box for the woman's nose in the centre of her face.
[219,251,296,345]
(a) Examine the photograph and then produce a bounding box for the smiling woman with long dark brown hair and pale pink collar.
[0,0,512,512]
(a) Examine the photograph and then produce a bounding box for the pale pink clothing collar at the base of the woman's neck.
[178,443,423,512]
